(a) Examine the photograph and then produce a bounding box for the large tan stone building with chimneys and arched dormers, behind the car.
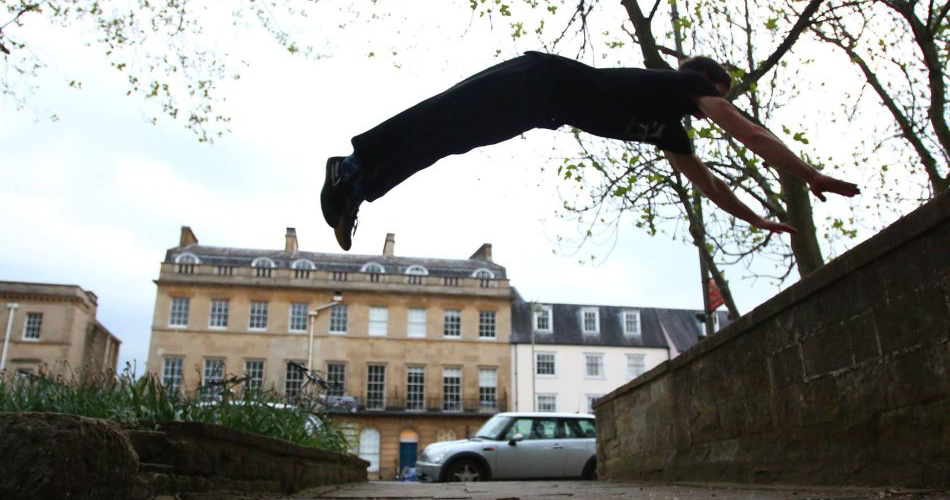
[147,227,512,479]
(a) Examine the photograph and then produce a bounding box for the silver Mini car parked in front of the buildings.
[416,412,597,482]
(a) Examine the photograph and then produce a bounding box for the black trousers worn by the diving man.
[352,52,594,201]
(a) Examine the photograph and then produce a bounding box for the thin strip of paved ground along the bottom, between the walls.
[278,481,950,500]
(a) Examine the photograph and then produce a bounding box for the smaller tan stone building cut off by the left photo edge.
[0,281,121,377]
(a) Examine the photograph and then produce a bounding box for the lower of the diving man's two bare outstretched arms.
[665,151,798,233]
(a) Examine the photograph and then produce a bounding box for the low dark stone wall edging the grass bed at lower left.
[0,412,368,500]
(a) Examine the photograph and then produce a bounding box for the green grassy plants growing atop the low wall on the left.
[0,365,347,452]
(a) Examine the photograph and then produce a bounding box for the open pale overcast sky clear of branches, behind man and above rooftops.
[0,2,888,371]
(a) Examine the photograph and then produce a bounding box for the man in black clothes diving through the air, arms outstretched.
[320,52,859,250]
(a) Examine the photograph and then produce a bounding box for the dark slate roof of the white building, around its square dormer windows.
[511,294,729,352]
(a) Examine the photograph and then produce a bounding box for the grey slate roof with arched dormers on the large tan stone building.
[165,245,507,279]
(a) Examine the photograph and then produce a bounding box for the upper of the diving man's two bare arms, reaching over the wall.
[696,96,861,201]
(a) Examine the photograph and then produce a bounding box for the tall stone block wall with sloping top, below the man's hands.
[596,189,950,488]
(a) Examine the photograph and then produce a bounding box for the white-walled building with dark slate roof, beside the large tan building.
[511,295,728,413]
